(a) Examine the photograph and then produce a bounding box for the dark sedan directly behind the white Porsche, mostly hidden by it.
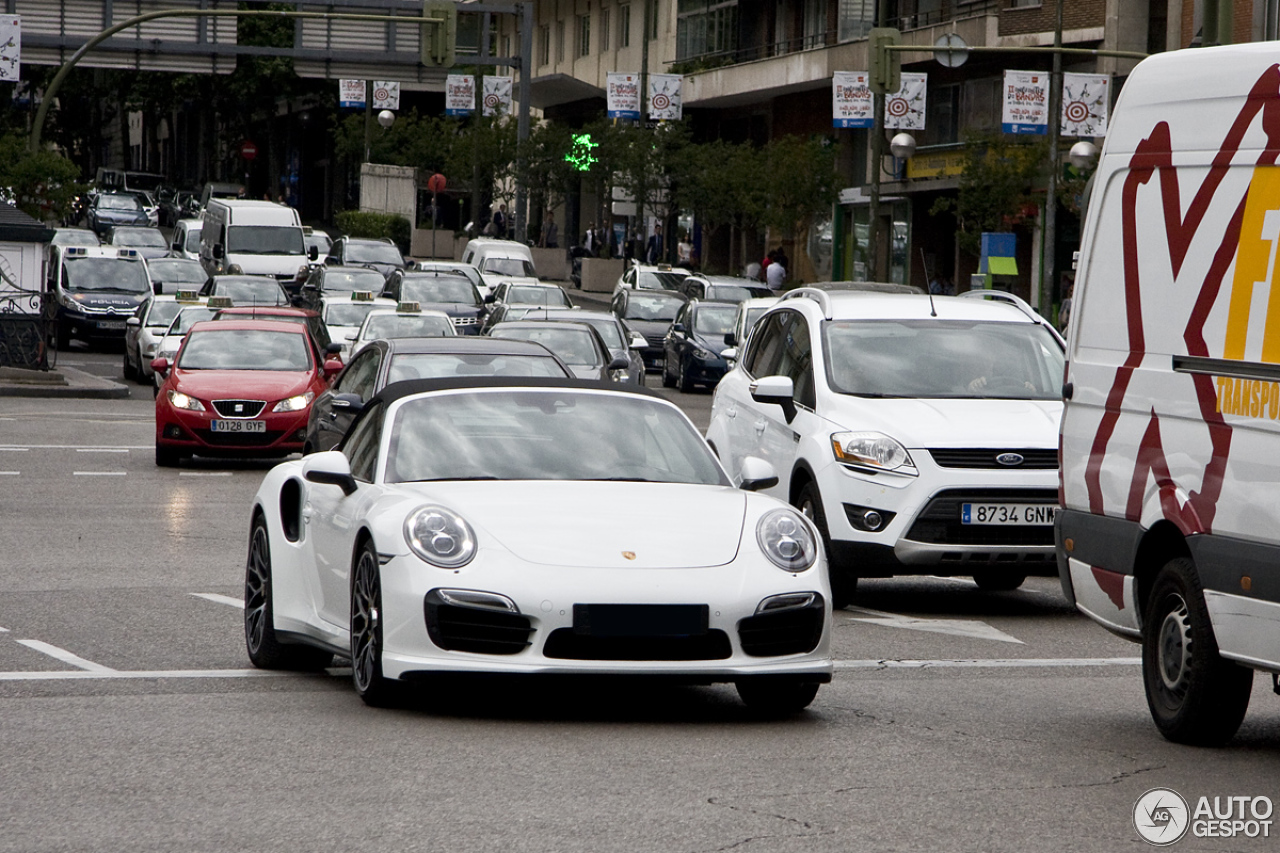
[302,337,573,453]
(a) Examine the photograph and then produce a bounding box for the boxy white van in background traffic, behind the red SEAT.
[200,199,319,282]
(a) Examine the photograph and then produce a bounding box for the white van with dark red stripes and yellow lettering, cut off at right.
[1056,42,1280,744]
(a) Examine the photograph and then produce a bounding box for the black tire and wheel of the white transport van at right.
[1142,557,1253,747]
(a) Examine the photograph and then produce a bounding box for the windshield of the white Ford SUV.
[823,320,1064,400]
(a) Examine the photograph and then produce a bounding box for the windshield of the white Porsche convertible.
[385,388,728,485]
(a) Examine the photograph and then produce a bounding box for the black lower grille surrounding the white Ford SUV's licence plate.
[904,489,1057,546]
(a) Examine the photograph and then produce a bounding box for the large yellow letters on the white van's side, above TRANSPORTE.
[1222,167,1280,362]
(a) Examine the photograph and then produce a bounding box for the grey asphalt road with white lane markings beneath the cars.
[0,345,1280,853]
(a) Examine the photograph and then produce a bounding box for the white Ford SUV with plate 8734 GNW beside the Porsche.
[707,288,1062,606]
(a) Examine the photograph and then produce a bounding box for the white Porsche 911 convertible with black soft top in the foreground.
[244,378,832,713]
